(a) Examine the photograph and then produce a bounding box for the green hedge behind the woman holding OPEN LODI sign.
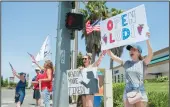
[101,83,169,107]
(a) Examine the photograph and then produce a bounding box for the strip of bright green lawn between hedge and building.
[145,82,169,92]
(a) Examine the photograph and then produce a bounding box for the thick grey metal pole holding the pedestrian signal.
[53,1,72,107]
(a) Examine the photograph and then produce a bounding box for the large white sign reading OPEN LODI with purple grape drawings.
[100,5,149,50]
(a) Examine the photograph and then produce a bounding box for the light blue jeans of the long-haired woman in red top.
[42,88,50,107]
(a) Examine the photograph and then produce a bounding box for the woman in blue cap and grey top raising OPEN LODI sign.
[107,33,153,107]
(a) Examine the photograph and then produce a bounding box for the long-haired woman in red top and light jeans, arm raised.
[33,60,54,107]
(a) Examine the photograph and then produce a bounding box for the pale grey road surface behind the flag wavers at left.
[1,89,76,107]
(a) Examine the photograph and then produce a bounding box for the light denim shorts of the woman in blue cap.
[123,84,148,102]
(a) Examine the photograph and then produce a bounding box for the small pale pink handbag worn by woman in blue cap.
[127,76,142,104]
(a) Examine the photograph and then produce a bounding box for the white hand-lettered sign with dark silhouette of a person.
[67,68,99,95]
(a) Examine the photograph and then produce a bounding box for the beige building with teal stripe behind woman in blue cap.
[113,47,169,82]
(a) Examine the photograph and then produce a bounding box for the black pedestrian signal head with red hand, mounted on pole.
[65,12,84,30]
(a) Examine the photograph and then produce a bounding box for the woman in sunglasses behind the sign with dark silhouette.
[79,51,106,107]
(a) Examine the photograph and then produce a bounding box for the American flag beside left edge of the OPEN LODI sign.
[86,19,101,34]
